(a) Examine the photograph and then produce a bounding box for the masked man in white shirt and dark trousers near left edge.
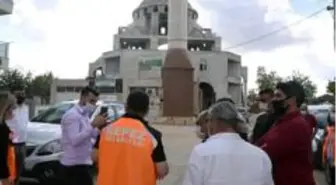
[7,87,29,185]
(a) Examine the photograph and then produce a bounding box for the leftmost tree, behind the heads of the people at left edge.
[0,69,32,91]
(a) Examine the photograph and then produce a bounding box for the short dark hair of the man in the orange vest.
[126,91,149,113]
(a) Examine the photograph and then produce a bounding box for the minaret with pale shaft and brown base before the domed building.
[162,0,194,117]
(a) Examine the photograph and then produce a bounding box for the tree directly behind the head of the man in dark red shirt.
[287,71,317,100]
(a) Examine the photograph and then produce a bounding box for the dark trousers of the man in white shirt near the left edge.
[14,143,26,185]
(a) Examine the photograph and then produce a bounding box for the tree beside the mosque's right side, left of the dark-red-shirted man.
[256,66,282,90]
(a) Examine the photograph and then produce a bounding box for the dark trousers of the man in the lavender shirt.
[62,165,93,185]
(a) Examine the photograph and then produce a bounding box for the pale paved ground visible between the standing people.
[24,125,327,185]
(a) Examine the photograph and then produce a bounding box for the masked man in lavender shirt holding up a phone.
[60,87,106,185]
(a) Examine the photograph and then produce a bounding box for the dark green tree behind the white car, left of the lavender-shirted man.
[30,72,53,104]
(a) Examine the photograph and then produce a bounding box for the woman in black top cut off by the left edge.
[0,93,15,185]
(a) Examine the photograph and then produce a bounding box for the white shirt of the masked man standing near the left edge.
[6,104,29,143]
